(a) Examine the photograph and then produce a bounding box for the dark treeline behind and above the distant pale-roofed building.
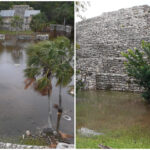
[0,2,74,26]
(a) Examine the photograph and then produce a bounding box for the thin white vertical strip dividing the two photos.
[74,1,76,149]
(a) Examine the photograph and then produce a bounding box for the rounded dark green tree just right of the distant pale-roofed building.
[30,13,47,32]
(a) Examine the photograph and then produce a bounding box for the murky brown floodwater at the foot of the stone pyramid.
[77,91,150,133]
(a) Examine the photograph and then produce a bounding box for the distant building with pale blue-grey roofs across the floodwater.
[0,5,40,31]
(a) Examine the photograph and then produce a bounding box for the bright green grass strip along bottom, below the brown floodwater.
[76,127,150,149]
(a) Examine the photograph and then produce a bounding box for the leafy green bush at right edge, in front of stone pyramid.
[122,41,150,102]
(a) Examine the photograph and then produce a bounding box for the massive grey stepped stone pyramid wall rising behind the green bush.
[76,5,150,91]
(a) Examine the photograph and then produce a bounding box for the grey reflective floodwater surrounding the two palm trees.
[0,39,74,142]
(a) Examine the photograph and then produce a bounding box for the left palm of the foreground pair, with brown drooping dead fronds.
[25,41,56,129]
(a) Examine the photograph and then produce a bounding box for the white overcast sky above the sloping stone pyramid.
[76,0,150,21]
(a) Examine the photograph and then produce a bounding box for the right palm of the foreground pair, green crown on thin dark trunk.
[55,37,73,132]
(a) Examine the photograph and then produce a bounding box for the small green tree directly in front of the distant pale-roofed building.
[11,16,23,31]
